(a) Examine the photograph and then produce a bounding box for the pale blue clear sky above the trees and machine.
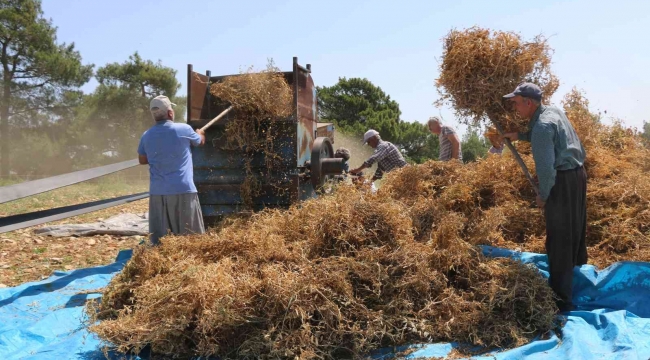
[43,0,650,136]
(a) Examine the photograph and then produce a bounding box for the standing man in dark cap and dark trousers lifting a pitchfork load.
[503,83,587,312]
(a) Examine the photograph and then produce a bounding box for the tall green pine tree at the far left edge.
[0,0,93,176]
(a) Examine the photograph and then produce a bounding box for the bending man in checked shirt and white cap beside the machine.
[350,129,407,181]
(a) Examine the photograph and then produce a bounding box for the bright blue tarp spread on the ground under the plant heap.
[0,247,650,360]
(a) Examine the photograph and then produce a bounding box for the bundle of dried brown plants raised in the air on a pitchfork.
[436,27,559,131]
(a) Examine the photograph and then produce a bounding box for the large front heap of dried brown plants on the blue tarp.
[89,185,556,359]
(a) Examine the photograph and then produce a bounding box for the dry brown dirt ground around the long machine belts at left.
[0,168,149,287]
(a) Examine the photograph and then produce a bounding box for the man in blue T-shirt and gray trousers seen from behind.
[138,95,205,245]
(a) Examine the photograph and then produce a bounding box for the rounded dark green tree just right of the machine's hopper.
[317,78,401,141]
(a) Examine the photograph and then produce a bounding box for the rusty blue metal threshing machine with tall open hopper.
[187,57,343,222]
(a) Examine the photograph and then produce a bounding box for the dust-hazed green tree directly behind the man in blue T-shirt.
[72,52,185,162]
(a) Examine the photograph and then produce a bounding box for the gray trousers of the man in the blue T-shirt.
[149,193,205,245]
